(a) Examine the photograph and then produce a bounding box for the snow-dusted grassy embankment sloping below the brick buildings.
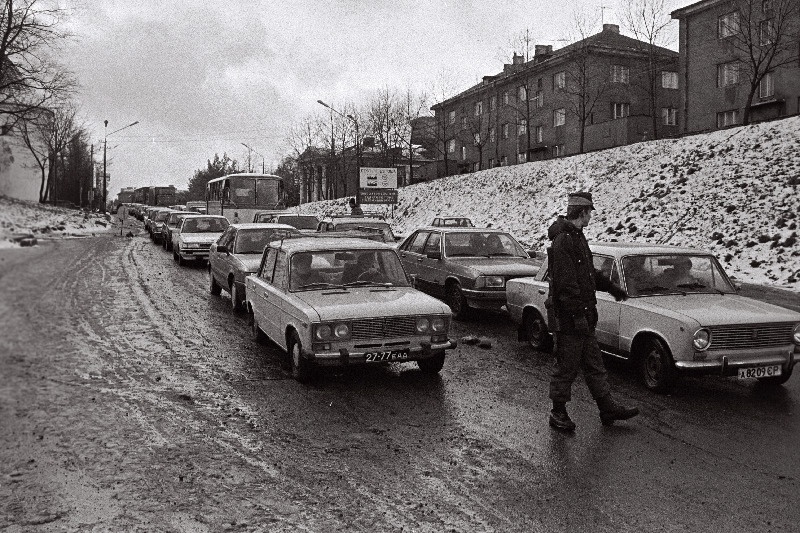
[302,116,800,290]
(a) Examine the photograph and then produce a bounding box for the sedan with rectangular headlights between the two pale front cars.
[399,226,539,319]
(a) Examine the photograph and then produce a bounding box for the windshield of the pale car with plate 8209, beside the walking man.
[622,254,736,296]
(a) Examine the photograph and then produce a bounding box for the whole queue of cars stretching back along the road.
[139,212,800,392]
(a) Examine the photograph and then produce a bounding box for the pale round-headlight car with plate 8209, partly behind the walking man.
[508,242,800,392]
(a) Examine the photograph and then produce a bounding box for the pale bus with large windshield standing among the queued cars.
[206,173,286,223]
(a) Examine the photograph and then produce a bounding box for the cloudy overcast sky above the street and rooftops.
[64,0,692,198]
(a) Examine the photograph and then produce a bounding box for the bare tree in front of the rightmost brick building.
[714,0,800,124]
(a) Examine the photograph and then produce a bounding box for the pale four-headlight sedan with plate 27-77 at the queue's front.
[245,237,456,381]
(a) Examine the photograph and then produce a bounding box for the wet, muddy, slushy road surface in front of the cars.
[0,234,800,533]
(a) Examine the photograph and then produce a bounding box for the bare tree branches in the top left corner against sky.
[0,0,75,127]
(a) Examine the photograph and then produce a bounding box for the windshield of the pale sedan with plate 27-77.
[289,250,409,291]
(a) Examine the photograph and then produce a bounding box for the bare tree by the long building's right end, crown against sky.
[620,0,673,139]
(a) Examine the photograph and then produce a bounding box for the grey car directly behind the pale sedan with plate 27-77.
[208,222,300,311]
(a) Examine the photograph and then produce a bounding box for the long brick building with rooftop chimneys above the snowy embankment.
[428,24,680,176]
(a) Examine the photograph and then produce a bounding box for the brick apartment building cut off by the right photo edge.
[672,0,800,133]
